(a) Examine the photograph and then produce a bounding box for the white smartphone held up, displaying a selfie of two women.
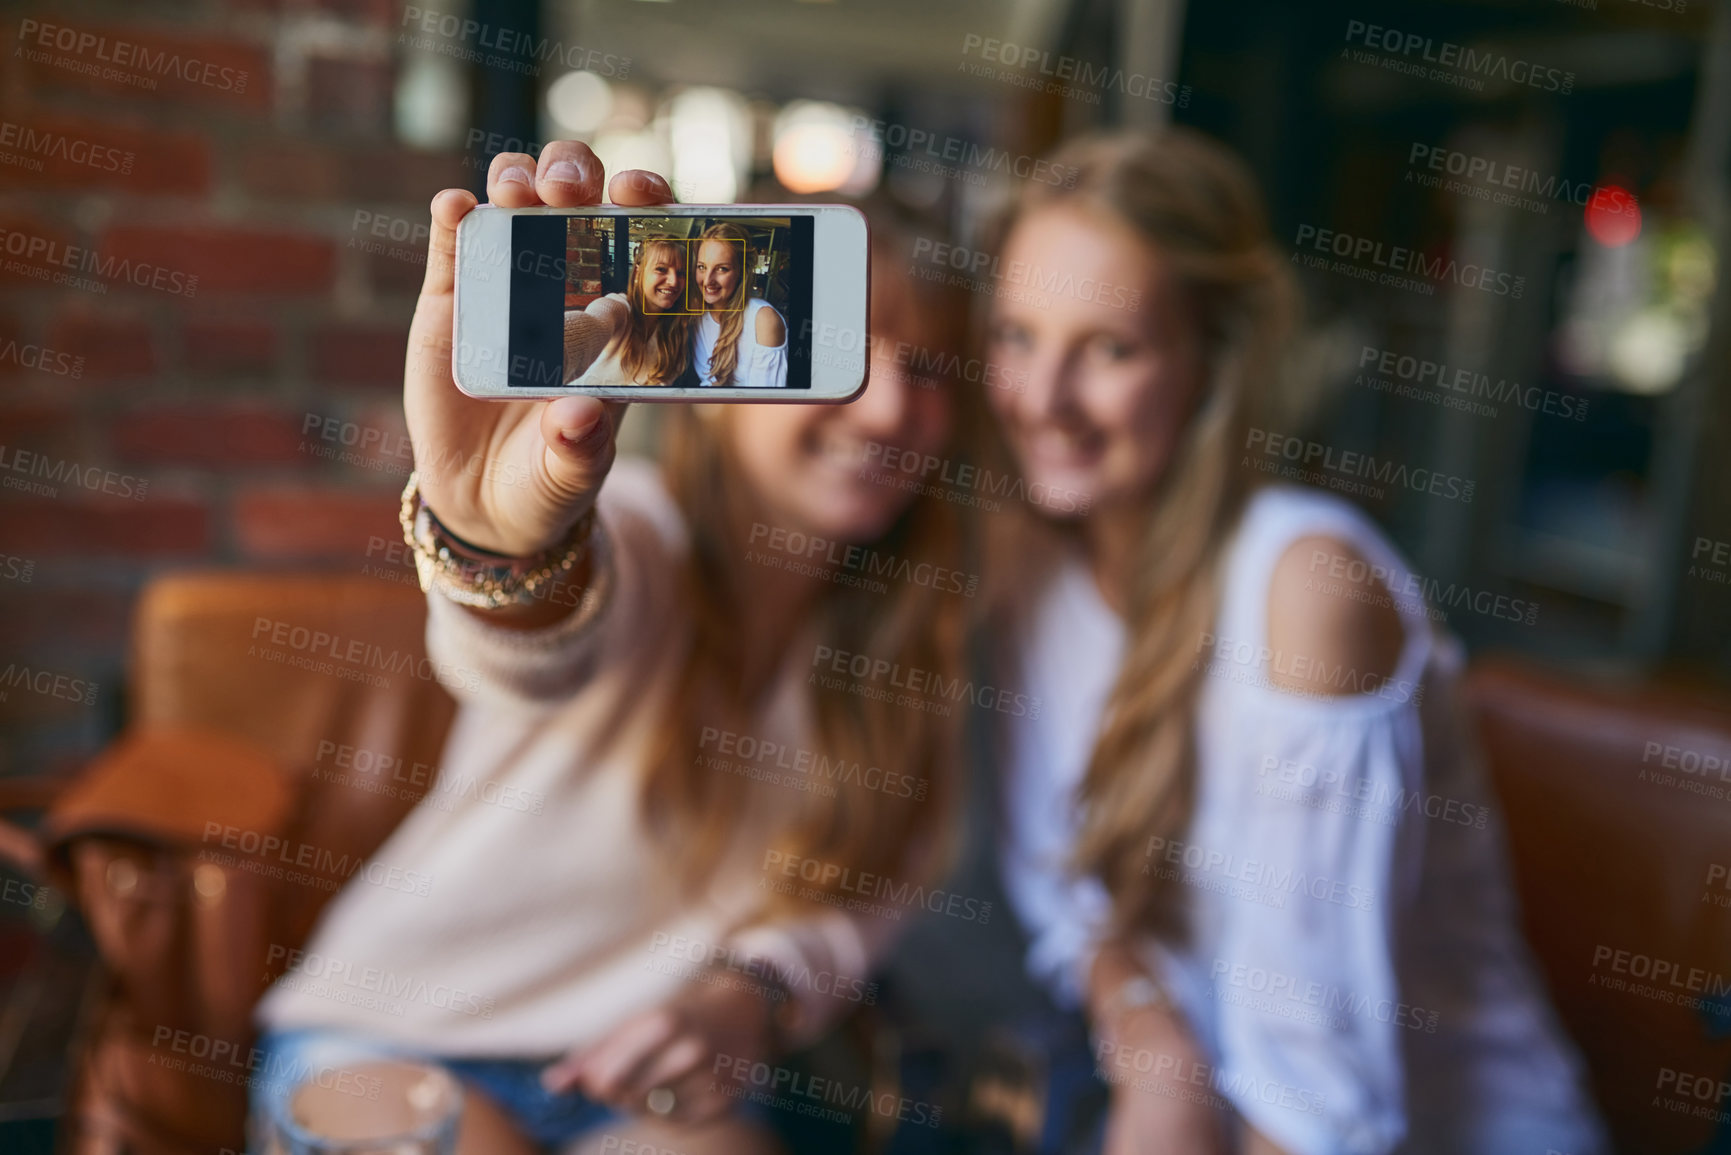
[450,204,871,402]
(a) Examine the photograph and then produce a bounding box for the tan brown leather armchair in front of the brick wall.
[0,573,455,1155]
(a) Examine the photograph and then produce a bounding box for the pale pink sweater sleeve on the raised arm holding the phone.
[426,459,685,705]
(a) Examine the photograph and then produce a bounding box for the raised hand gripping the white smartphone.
[403,140,673,623]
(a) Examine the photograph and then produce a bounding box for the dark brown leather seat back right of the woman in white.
[1468,660,1731,1152]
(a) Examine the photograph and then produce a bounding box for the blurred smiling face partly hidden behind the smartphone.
[727,252,956,544]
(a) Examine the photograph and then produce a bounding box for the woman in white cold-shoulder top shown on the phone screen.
[691,222,788,390]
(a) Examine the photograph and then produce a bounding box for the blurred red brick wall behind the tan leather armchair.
[0,0,476,774]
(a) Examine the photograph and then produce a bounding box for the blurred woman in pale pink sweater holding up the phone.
[256,142,961,1155]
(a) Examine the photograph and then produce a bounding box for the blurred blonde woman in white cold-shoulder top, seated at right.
[987,130,1605,1155]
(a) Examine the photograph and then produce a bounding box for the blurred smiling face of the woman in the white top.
[987,204,1203,513]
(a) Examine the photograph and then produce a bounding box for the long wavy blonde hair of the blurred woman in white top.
[988,128,1295,939]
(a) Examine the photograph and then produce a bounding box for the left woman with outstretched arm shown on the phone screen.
[564,237,691,386]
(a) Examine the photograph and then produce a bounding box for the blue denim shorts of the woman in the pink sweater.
[249,1027,620,1153]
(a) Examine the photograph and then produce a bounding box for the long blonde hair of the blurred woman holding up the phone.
[640,206,968,914]
